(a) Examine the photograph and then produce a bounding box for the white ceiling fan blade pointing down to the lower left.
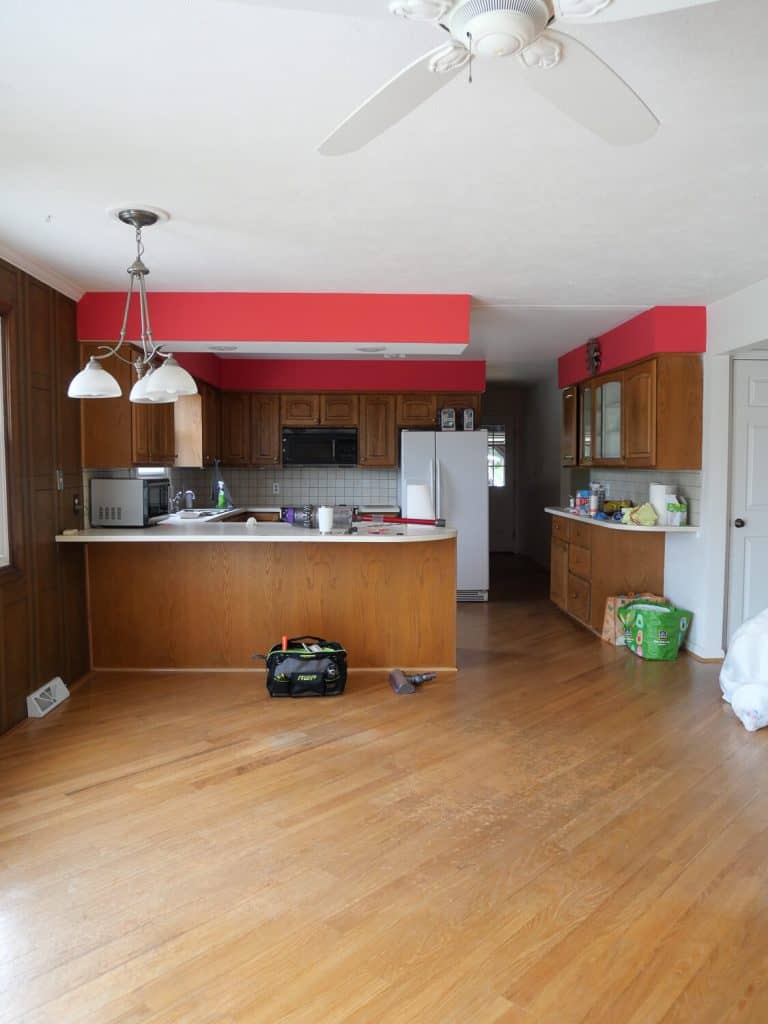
[317,46,461,157]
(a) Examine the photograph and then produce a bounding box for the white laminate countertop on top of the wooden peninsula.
[56,520,456,544]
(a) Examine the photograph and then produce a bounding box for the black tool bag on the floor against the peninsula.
[264,637,347,697]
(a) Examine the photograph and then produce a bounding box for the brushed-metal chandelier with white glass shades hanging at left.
[67,209,198,404]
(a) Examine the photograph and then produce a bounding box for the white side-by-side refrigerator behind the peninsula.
[399,430,488,601]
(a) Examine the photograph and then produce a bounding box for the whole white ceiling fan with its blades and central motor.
[228,0,717,156]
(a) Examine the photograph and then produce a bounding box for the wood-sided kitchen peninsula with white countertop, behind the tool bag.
[56,522,456,670]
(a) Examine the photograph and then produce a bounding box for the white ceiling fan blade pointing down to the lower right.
[522,31,658,145]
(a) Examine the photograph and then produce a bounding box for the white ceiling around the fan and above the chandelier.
[0,0,768,379]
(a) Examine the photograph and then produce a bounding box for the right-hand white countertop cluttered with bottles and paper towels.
[545,481,697,532]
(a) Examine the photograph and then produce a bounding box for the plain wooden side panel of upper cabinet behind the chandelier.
[80,345,133,469]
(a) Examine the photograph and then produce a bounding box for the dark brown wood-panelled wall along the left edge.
[0,261,88,731]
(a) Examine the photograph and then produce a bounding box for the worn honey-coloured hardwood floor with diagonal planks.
[0,561,768,1024]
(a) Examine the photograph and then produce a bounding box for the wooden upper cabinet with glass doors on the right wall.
[562,354,702,470]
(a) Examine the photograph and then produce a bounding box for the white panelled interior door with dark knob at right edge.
[728,359,768,640]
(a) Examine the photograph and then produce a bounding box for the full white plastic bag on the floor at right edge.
[720,608,768,732]
